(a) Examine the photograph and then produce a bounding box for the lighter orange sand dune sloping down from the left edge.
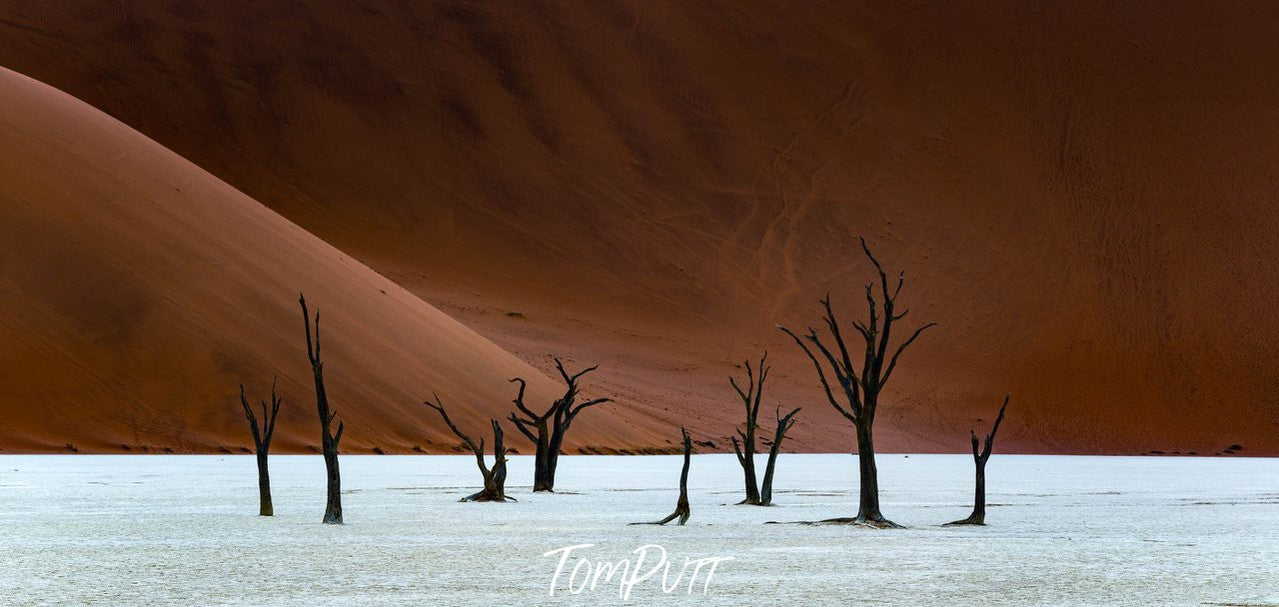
[0,70,661,452]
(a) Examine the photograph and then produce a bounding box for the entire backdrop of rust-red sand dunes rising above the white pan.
[0,0,1279,455]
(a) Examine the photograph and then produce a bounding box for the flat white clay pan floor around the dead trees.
[0,454,1279,606]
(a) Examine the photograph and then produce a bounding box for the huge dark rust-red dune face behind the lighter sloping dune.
[0,0,1279,454]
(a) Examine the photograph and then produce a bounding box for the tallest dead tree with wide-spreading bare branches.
[778,239,936,528]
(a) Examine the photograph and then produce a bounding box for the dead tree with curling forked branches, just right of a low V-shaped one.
[509,358,613,492]
